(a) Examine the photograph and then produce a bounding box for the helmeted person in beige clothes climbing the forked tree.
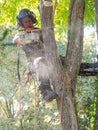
[13,9,58,102]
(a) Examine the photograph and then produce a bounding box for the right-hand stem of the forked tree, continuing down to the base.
[62,0,84,130]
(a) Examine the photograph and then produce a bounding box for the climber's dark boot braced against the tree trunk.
[39,80,58,102]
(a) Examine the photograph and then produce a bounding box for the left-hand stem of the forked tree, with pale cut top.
[39,0,63,96]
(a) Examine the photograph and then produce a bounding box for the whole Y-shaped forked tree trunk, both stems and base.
[39,0,84,130]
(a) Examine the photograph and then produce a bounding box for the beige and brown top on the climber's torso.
[14,29,44,59]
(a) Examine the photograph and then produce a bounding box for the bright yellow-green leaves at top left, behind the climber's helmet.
[0,0,38,24]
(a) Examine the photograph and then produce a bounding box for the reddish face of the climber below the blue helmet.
[22,16,33,29]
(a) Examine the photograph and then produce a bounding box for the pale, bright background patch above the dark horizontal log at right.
[82,27,97,63]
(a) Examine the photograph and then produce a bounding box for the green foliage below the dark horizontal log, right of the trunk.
[76,77,96,130]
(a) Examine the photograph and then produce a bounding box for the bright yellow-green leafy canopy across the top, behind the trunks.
[0,0,95,26]
